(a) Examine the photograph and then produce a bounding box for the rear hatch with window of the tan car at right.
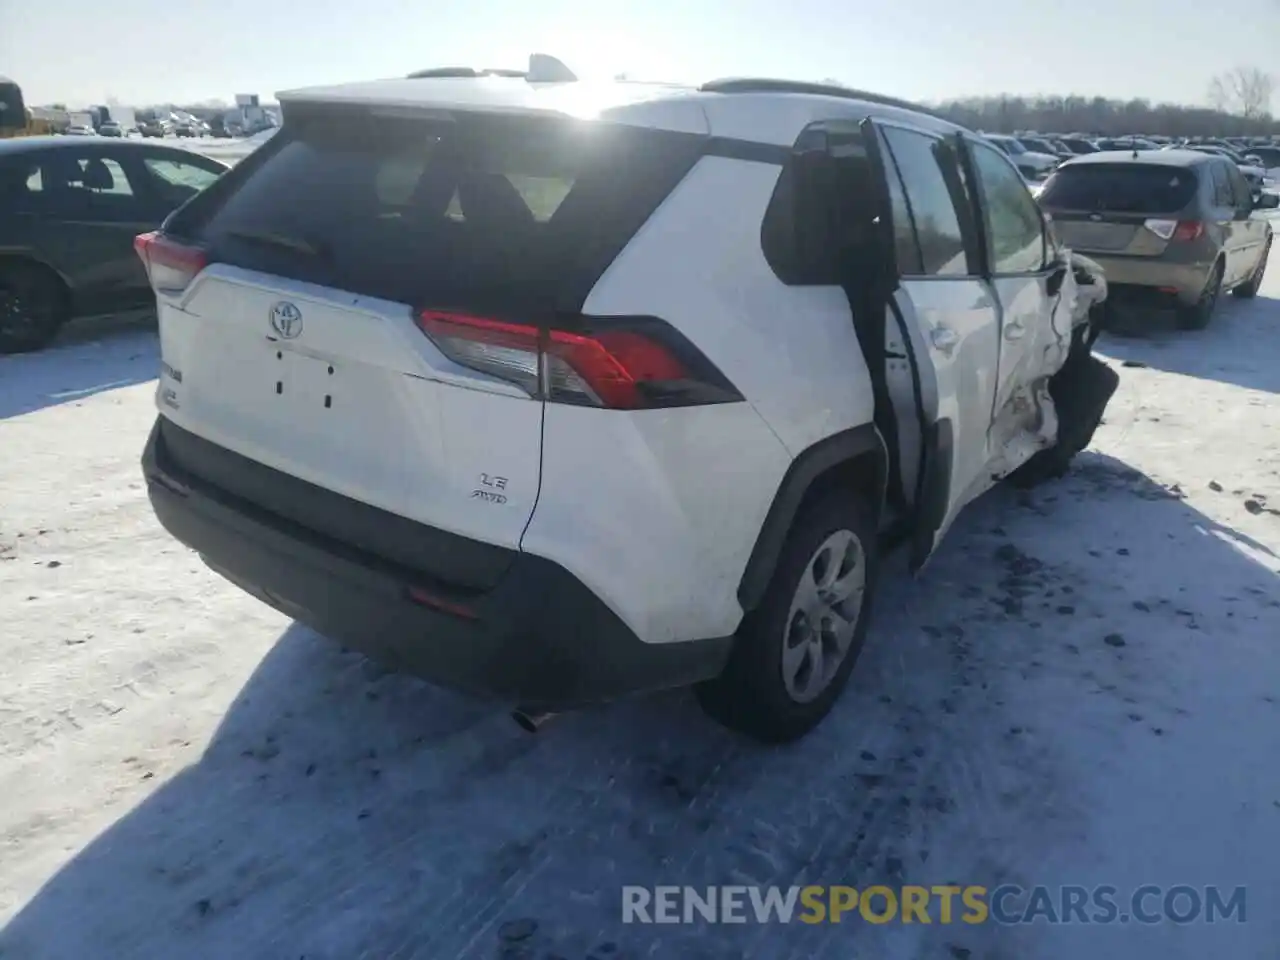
[1038,163,1198,257]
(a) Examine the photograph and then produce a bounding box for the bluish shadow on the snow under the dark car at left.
[0,314,160,420]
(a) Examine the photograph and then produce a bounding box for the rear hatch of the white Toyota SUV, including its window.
[140,102,700,588]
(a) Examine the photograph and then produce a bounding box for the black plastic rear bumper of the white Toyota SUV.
[142,421,731,710]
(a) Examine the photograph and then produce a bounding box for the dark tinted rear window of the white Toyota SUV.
[165,105,701,310]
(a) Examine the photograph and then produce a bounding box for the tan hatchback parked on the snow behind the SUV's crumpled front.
[1038,150,1280,329]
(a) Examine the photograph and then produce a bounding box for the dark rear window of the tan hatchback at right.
[1039,164,1197,214]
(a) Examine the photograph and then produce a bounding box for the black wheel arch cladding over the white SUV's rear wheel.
[737,424,888,611]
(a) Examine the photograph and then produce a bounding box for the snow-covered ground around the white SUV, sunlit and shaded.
[0,276,1280,960]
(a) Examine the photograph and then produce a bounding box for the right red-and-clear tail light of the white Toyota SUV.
[417,310,742,410]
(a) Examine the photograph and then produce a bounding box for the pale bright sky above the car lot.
[0,0,1280,108]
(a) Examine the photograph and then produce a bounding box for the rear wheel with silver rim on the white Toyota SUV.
[695,493,879,744]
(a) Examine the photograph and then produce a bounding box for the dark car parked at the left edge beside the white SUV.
[0,137,227,353]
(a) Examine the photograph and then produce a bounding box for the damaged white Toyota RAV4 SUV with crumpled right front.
[137,62,1115,740]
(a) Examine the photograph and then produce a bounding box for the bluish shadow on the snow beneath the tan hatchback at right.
[1098,294,1280,393]
